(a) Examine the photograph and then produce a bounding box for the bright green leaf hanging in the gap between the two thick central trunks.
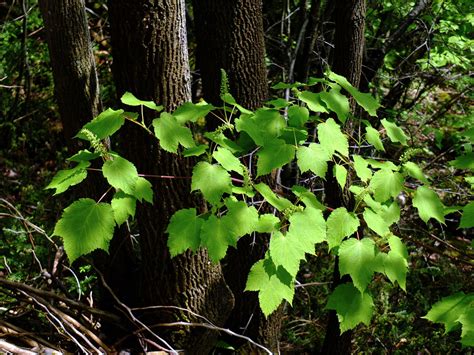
[191,161,232,204]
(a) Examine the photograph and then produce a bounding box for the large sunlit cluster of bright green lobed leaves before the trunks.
[48,72,466,338]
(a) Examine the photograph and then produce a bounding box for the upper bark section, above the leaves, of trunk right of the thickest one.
[193,0,268,109]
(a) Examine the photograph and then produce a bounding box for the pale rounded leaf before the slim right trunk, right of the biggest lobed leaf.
[326,207,360,249]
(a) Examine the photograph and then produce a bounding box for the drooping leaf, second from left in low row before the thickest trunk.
[201,215,238,263]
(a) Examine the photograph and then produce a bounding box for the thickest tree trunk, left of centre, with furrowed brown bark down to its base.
[109,0,233,354]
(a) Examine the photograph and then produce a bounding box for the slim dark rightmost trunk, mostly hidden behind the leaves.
[321,0,366,354]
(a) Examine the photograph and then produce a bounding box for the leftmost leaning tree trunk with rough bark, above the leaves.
[39,0,101,142]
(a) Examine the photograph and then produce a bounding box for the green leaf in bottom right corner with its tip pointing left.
[421,292,474,333]
